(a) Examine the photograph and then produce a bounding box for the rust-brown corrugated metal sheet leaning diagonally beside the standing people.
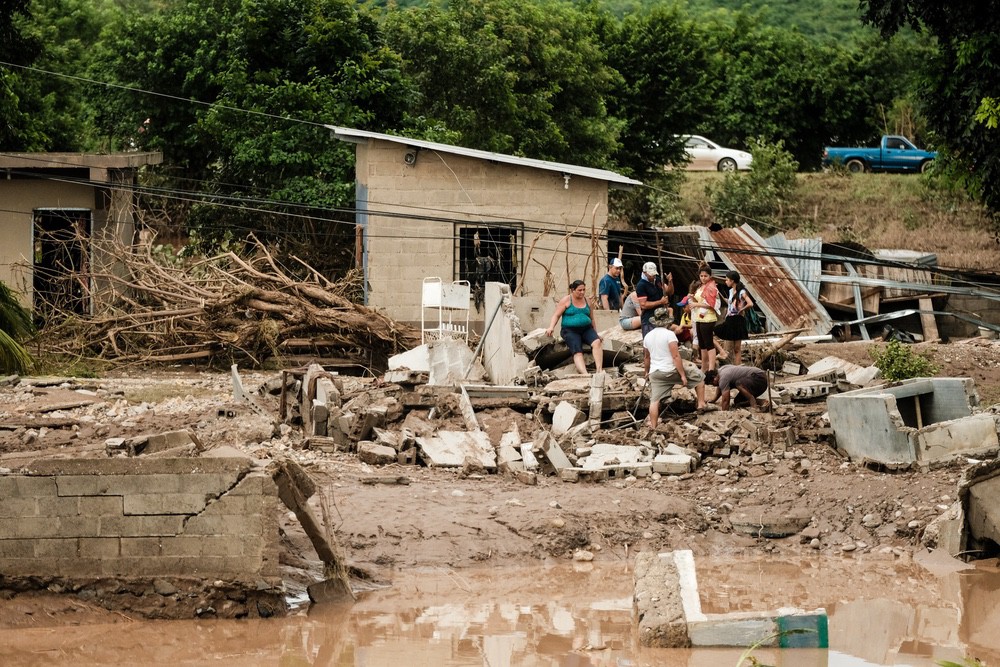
[710,225,833,334]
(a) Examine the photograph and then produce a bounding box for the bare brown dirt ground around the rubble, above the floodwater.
[0,339,1000,627]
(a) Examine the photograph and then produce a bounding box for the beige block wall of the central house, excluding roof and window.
[357,140,608,323]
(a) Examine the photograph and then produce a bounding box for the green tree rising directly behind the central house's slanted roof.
[382,0,619,167]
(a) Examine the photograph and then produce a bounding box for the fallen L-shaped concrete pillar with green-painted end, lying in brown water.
[633,550,829,648]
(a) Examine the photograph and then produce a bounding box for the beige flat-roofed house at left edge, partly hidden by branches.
[0,152,162,314]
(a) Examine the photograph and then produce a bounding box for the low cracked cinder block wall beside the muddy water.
[0,458,280,583]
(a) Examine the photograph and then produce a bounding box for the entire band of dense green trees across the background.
[0,0,1000,260]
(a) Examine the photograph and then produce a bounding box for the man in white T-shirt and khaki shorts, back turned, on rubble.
[642,308,705,428]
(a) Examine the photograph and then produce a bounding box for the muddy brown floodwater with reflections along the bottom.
[0,555,1000,667]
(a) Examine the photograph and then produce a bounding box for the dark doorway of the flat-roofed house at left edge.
[33,208,91,320]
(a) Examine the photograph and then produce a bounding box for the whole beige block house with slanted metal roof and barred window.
[327,126,641,323]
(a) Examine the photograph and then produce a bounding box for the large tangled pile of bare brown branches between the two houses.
[36,239,420,366]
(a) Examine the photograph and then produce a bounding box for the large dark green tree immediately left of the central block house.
[94,0,408,268]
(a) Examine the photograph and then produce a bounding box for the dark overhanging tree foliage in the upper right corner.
[861,0,1000,217]
